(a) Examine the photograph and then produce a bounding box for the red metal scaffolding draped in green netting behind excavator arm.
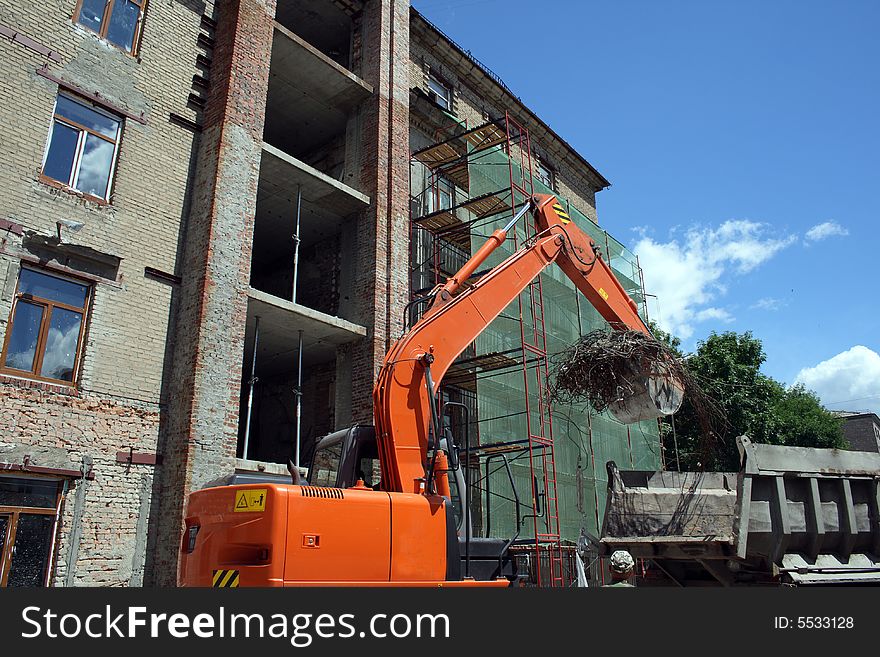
[408,114,660,586]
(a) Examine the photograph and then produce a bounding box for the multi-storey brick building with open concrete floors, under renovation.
[0,0,659,586]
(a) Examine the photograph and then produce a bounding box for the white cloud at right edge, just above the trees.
[795,345,880,413]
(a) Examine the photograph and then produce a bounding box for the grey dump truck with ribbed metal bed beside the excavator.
[599,436,880,586]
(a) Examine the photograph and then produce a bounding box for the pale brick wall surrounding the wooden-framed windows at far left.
[0,0,214,585]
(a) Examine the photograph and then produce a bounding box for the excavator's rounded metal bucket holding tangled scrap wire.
[608,356,684,424]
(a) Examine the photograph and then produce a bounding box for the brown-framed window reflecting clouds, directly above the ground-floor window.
[0,267,91,383]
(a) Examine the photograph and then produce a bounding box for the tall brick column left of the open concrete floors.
[145,0,275,586]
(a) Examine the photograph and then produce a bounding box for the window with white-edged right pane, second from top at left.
[43,94,122,200]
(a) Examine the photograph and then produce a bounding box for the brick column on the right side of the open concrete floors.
[351,0,410,422]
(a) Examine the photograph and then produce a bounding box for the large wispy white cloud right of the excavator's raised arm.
[634,220,796,340]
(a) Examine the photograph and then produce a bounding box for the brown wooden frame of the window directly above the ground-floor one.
[0,265,95,388]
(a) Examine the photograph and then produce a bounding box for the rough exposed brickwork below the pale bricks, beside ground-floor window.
[0,382,159,586]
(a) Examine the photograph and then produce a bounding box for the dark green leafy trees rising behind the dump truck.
[657,331,845,471]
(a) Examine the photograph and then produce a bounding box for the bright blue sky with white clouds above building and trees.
[413,0,880,411]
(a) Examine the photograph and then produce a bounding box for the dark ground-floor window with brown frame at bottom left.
[0,477,60,588]
